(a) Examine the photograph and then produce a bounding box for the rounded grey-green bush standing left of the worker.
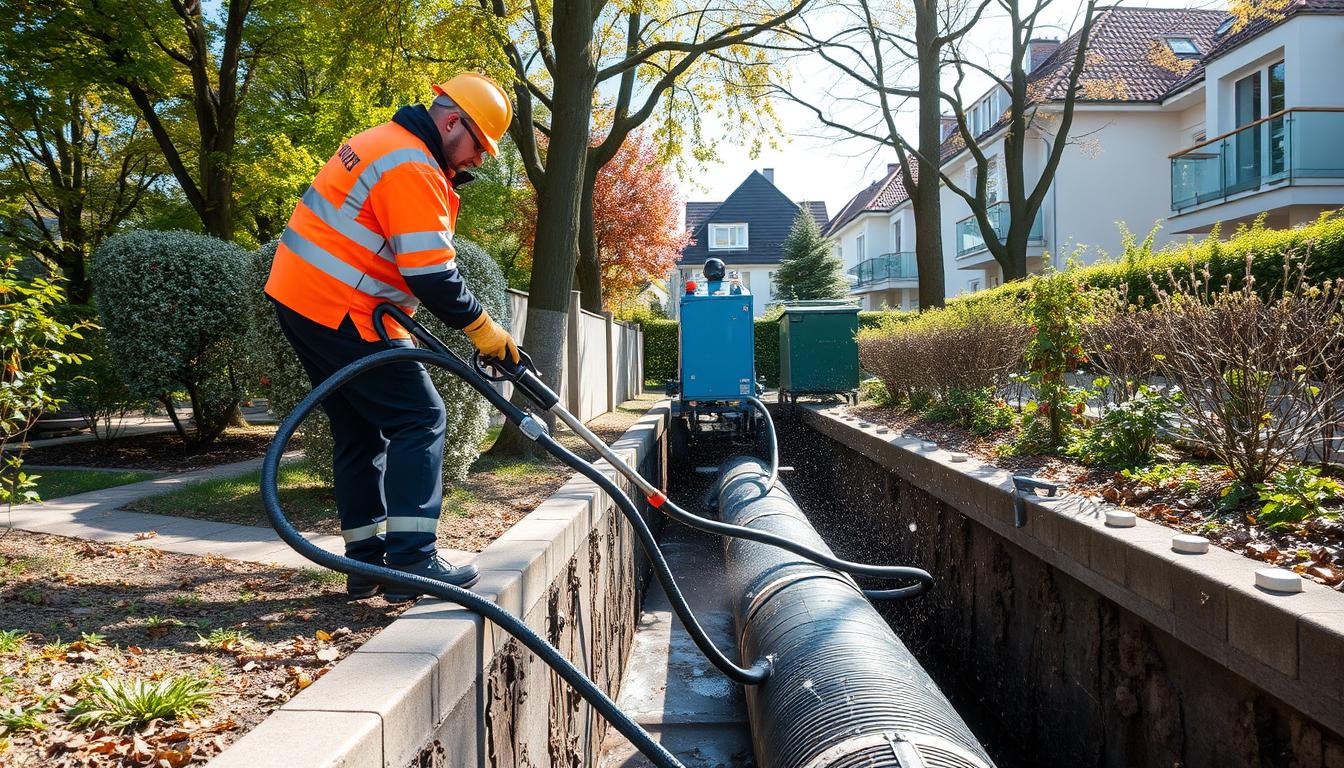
[93,230,253,444]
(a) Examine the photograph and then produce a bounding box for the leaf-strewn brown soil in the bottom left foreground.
[0,530,405,768]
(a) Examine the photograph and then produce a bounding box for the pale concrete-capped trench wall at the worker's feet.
[211,405,667,768]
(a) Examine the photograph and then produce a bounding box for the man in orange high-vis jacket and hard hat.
[266,73,519,603]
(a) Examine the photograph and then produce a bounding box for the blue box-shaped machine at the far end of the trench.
[668,258,761,449]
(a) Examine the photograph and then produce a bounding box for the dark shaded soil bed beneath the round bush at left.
[23,425,283,472]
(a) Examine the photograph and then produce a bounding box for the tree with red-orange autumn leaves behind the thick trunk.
[520,133,691,309]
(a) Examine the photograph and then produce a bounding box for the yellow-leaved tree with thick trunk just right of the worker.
[462,0,810,455]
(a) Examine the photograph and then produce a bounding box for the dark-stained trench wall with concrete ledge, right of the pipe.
[784,410,1344,768]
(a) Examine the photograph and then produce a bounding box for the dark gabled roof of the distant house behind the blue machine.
[680,171,825,266]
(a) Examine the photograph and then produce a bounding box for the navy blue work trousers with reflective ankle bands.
[273,301,445,566]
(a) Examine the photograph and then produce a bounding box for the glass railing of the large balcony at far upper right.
[1171,108,1344,213]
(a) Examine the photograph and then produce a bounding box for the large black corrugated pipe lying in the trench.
[715,457,993,768]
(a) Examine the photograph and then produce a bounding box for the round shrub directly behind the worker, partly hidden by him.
[253,238,512,484]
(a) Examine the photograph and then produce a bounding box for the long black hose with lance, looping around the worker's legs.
[261,304,933,768]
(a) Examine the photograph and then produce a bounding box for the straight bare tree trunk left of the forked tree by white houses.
[910,0,948,309]
